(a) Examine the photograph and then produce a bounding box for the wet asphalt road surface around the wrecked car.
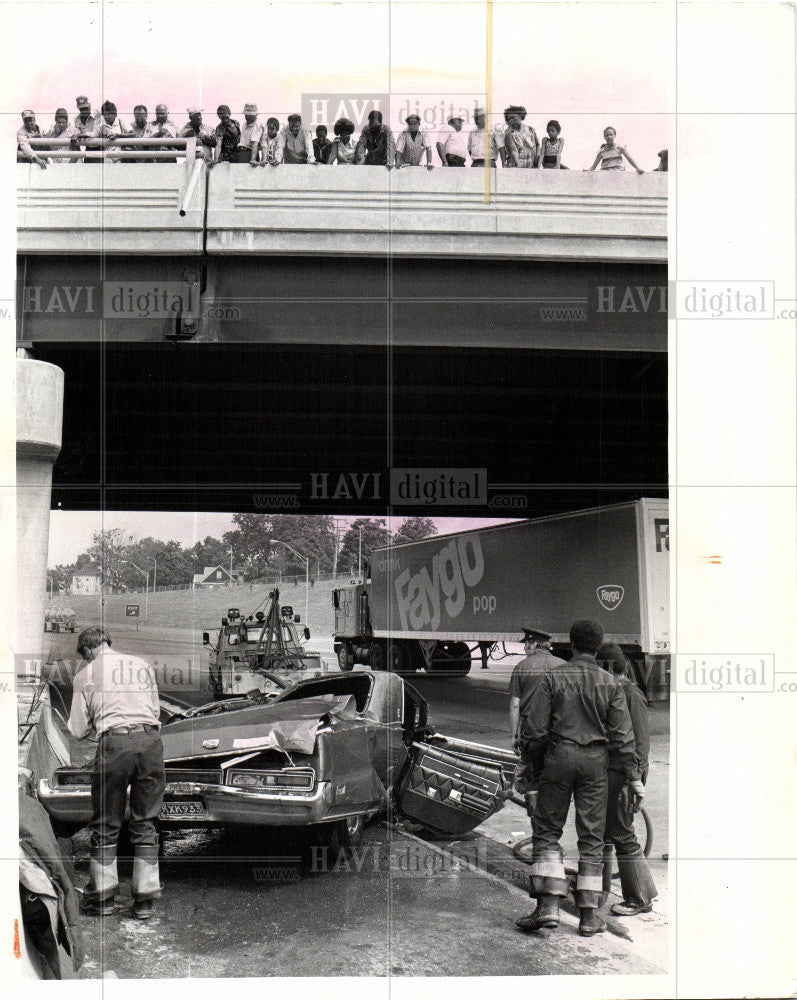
[40,627,667,978]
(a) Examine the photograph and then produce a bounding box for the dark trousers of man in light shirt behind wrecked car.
[89,732,166,862]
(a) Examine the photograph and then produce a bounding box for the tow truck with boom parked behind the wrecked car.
[202,589,328,699]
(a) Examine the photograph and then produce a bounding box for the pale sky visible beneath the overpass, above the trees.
[47,510,515,569]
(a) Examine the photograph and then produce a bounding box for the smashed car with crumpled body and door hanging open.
[38,670,516,844]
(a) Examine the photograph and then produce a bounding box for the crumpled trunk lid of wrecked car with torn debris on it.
[161,696,354,762]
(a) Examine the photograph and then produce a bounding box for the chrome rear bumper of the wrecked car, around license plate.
[38,779,380,828]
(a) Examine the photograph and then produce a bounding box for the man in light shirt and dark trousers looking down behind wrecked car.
[69,627,166,920]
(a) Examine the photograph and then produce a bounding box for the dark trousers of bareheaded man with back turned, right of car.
[532,741,608,907]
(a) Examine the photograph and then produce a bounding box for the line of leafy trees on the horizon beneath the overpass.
[48,514,437,592]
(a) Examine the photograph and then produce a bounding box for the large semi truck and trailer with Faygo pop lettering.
[333,498,670,696]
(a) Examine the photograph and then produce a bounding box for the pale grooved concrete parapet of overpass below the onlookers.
[18,163,667,262]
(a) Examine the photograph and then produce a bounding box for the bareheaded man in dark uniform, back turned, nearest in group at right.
[517,620,644,937]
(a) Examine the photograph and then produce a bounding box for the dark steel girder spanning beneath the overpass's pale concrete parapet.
[17,254,667,351]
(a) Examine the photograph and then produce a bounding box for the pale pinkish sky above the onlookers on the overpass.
[0,0,674,169]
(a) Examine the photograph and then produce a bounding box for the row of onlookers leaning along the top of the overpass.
[17,97,667,174]
